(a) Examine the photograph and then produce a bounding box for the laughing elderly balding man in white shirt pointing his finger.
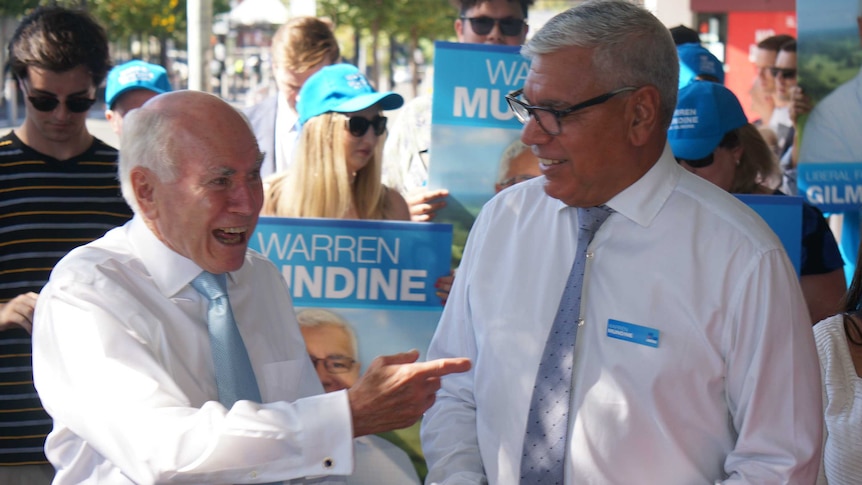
[33,91,469,485]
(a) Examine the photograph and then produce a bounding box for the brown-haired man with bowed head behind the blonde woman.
[246,17,341,178]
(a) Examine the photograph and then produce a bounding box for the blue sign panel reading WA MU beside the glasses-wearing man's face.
[431,42,530,130]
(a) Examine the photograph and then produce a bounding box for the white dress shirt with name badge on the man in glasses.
[422,148,821,485]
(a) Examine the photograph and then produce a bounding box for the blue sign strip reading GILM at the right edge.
[796,162,862,212]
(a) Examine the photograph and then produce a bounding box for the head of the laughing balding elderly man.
[120,91,263,274]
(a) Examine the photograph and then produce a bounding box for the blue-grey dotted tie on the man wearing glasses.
[521,206,613,485]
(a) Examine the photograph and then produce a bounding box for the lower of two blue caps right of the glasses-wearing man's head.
[667,81,748,160]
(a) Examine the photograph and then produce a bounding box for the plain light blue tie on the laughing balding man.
[192,271,261,409]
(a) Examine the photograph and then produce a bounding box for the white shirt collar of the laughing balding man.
[129,215,238,298]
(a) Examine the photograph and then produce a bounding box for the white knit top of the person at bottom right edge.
[814,315,862,485]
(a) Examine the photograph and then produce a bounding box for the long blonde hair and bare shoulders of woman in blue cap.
[262,113,386,219]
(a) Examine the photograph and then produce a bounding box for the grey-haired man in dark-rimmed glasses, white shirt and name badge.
[421,0,822,485]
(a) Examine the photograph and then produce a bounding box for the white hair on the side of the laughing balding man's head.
[119,108,178,214]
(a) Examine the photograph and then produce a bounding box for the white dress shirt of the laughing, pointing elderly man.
[33,217,353,485]
